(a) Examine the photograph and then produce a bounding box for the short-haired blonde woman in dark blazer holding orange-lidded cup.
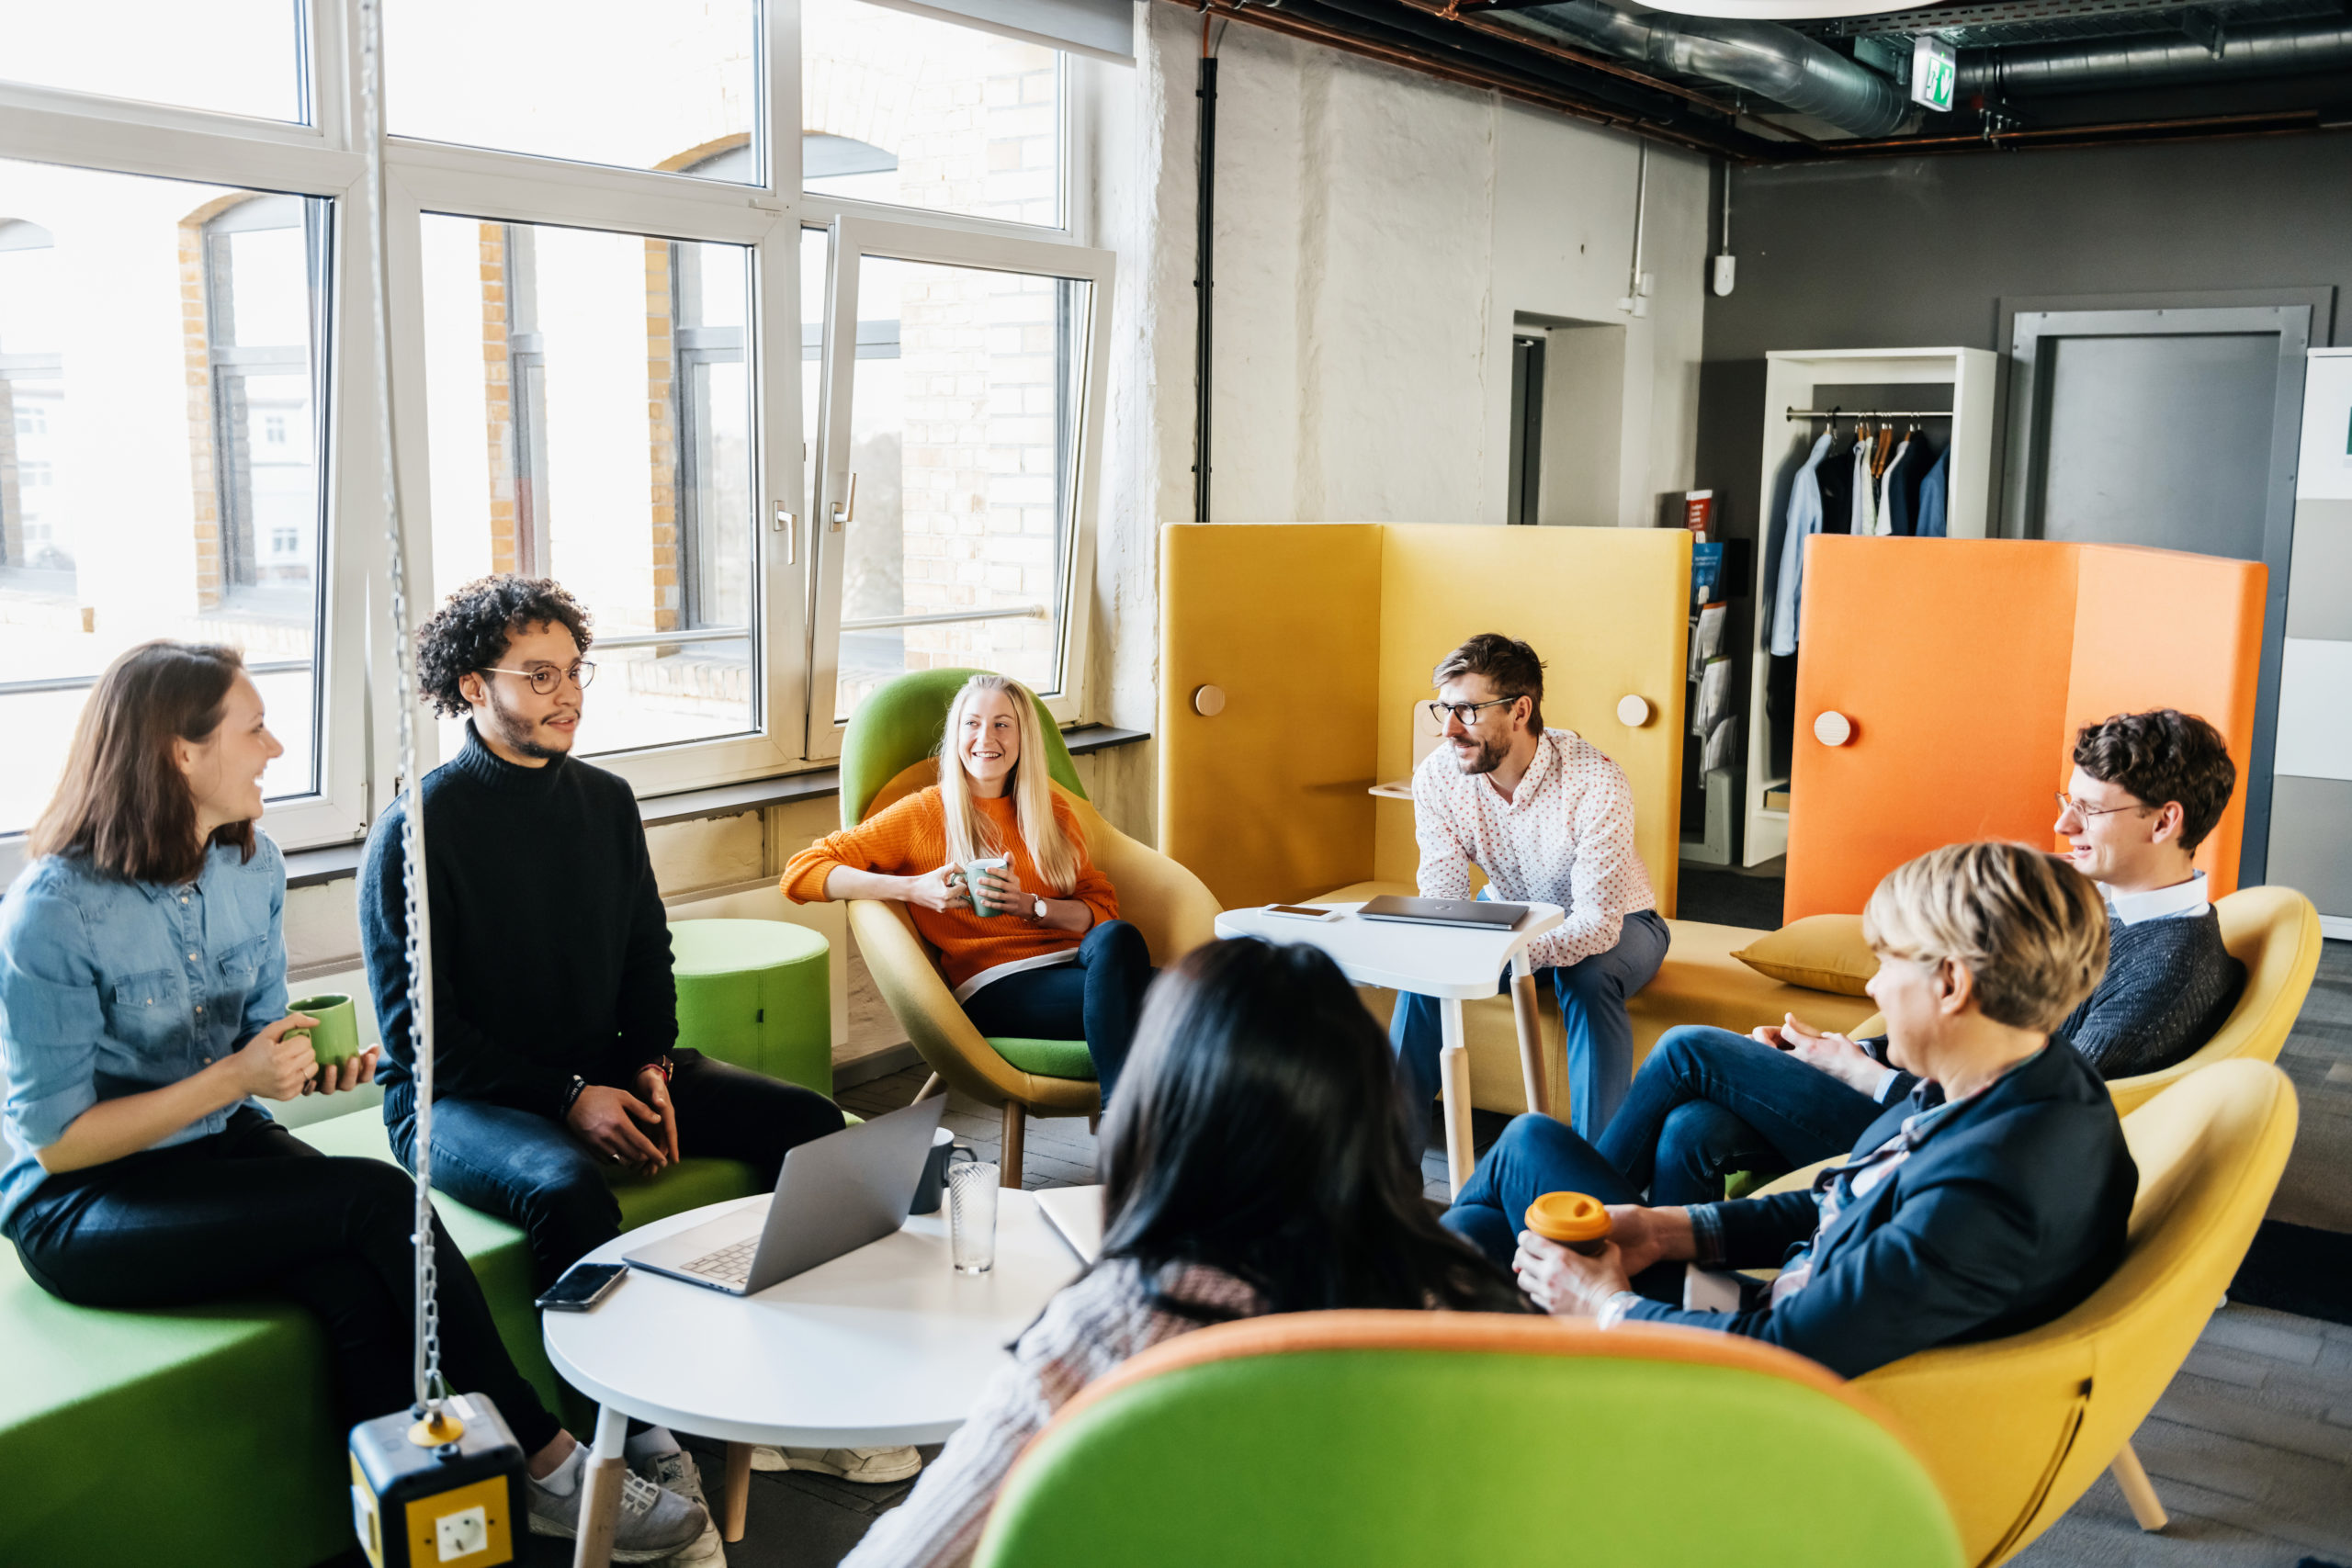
[1446,844,2138,1378]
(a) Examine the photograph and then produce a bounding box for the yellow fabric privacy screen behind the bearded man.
[1158,522,1691,915]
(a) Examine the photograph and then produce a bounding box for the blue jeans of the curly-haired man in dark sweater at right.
[1600,1025,1886,1208]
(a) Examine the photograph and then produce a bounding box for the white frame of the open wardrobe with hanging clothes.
[1740,348,2002,865]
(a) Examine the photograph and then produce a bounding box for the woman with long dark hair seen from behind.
[842,941,1526,1568]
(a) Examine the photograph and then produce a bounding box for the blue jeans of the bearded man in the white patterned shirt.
[1387,894,1670,1138]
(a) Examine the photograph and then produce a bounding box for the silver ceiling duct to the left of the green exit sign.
[1498,0,1910,139]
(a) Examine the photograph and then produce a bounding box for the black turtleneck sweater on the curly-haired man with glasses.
[360,722,677,1126]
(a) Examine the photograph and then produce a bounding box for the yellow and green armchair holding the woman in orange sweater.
[842,670,1218,1187]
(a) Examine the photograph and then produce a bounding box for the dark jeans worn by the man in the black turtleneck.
[386,1051,842,1291]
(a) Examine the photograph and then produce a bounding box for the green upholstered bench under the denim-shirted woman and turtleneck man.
[0,1107,751,1568]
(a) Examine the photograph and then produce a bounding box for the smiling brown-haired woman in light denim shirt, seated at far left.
[0,642,703,1556]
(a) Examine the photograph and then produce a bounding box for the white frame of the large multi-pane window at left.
[0,0,1114,877]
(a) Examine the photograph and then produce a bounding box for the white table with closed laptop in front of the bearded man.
[1216,900,1566,1192]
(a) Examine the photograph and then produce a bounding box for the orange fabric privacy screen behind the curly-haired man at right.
[1782,534,2265,919]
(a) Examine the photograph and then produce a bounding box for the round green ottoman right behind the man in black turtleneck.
[671,919,832,1098]
